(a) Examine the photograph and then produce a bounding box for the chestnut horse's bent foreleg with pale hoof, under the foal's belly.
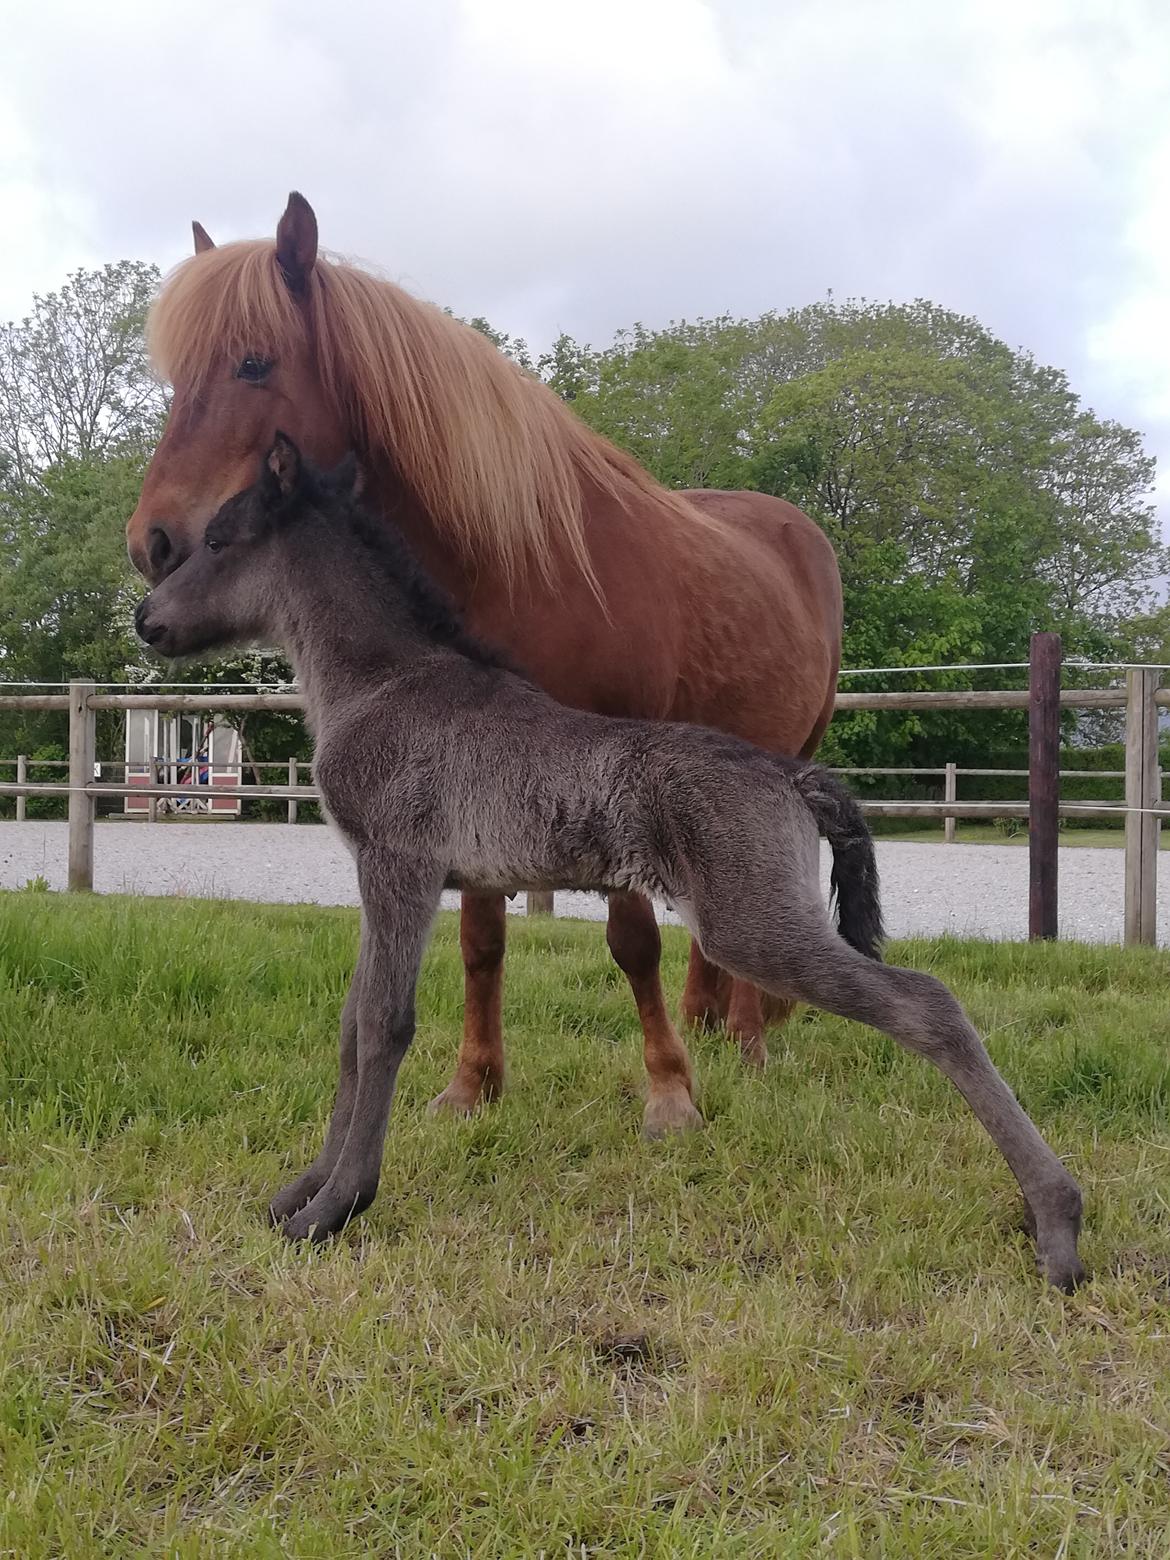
[605,894,702,1137]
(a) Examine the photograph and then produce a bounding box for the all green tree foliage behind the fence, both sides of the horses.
[0,277,1170,792]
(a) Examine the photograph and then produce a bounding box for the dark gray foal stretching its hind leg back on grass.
[136,434,1084,1290]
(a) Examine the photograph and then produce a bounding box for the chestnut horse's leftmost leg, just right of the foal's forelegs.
[431,894,507,1115]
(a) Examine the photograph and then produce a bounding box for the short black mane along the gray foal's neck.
[301,462,511,675]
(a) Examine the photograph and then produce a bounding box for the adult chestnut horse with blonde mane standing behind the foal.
[126,193,841,1134]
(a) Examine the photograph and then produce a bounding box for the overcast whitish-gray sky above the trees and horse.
[0,0,1170,519]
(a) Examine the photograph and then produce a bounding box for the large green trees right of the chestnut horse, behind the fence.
[540,298,1165,763]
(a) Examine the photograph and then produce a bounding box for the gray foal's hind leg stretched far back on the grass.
[723,927,1084,1290]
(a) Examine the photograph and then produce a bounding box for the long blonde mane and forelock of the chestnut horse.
[148,240,714,588]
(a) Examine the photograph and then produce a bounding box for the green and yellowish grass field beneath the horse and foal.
[0,892,1170,1560]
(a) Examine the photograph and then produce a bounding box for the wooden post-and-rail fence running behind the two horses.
[0,635,1170,944]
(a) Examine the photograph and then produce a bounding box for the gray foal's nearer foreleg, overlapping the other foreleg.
[282,852,443,1240]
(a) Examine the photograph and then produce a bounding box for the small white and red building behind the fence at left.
[126,710,242,817]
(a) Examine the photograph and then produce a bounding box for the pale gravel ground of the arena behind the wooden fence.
[0,819,1170,944]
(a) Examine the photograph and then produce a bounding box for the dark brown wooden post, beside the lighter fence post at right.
[1028,633,1061,939]
